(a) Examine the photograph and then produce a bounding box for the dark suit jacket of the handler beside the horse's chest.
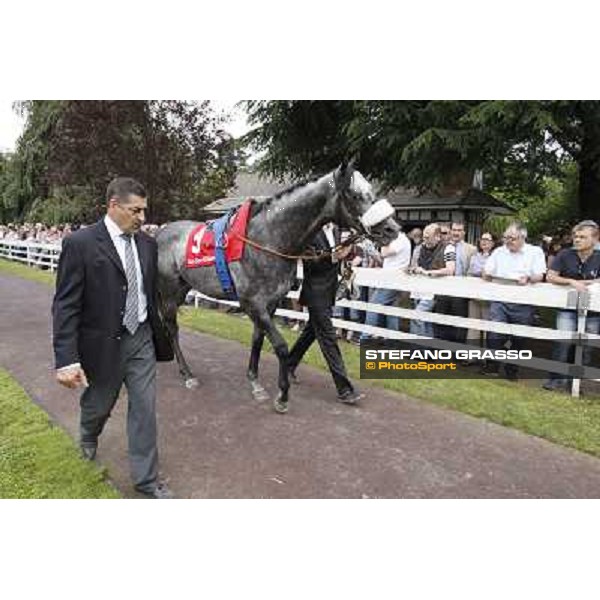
[300,227,340,308]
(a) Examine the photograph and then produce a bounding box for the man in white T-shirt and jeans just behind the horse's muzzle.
[360,232,411,341]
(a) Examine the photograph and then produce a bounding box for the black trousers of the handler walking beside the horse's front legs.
[288,306,354,395]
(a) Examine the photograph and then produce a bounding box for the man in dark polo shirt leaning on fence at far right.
[543,220,600,391]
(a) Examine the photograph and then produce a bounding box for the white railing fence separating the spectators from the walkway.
[0,240,600,396]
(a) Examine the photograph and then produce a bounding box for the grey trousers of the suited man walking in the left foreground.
[80,321,158,490]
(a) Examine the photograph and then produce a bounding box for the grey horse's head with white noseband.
[333,163,400,246]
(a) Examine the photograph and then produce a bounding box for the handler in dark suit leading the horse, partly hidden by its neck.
[288,226,362,404]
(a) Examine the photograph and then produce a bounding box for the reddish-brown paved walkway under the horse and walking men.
[0,274,600,498]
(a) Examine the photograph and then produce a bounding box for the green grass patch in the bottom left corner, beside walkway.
[0,369,120,498]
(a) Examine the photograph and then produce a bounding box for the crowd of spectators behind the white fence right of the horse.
[330,220,600,390]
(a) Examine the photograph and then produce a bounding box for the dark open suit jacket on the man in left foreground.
[52,219,173,384]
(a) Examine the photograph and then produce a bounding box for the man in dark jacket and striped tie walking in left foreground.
[52,177,173,499]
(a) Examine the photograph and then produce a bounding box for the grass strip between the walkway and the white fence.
[180,308,600,456]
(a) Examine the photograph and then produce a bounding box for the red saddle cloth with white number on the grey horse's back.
[185,200,252,269]
